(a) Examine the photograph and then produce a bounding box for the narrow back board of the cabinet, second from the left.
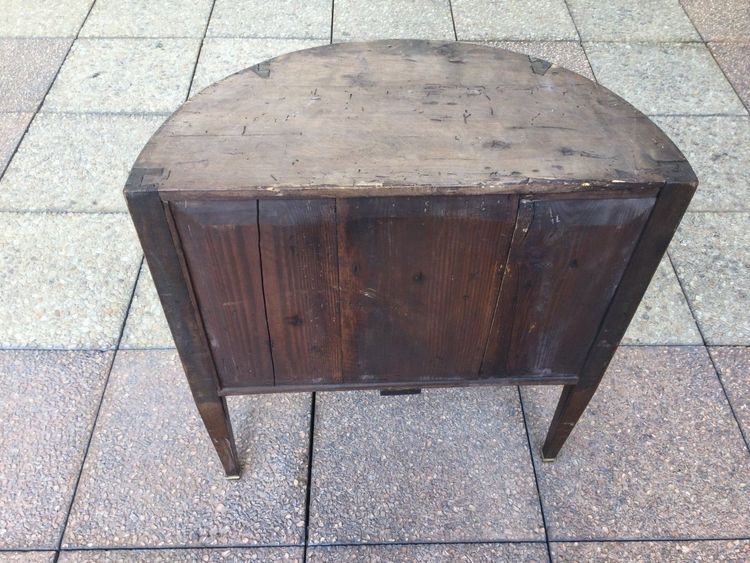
[259,199,341,385]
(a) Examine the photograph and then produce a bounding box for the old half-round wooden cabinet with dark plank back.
[126,41,697,476]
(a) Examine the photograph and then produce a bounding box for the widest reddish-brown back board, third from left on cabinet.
[337,196,518,382]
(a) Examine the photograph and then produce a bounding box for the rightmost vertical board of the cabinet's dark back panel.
[482,197,655,376]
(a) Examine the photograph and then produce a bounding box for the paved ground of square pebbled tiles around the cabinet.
[0,0,750,562]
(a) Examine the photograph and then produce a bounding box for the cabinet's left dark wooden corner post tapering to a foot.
[127,187,240,478]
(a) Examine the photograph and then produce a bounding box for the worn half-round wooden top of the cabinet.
[127,40,696,197]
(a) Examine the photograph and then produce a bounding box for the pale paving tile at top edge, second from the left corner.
[81,0,211,38]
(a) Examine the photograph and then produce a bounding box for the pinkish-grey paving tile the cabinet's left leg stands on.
[63,350,310,548]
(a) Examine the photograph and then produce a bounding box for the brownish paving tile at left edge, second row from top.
[0,39,70,112]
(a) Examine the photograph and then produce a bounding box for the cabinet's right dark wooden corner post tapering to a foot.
[542,185,695,461]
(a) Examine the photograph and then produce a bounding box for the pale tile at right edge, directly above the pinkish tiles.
[669,213,750,345]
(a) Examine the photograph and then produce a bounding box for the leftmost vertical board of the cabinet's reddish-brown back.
[172,200,274,387]
